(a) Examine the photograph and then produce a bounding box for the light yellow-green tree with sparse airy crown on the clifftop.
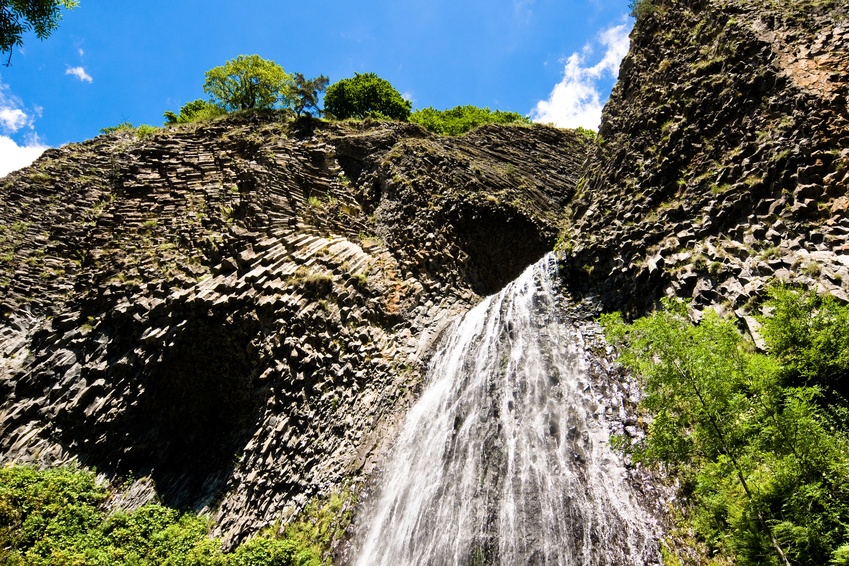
[203,55,293,110]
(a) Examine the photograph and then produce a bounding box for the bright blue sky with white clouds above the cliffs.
[0,0,632,175]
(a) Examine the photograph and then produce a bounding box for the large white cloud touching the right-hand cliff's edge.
[531,23,631,130]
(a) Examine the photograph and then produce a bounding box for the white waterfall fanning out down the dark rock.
[354,256,656,566]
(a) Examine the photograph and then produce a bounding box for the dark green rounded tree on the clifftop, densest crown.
[324,73,412,121]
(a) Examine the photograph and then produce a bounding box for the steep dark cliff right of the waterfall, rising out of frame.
[566,0,849,316]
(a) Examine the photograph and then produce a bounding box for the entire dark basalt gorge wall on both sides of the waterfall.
[0,0,849,560]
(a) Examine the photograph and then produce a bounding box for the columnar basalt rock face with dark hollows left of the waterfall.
[0,112,587,542]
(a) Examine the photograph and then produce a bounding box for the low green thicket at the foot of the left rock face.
[0,466,350,566]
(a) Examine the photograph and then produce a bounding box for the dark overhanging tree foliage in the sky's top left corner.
[0,0,79,67]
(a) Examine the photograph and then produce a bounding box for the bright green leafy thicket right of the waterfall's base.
[601,288,849,566]
